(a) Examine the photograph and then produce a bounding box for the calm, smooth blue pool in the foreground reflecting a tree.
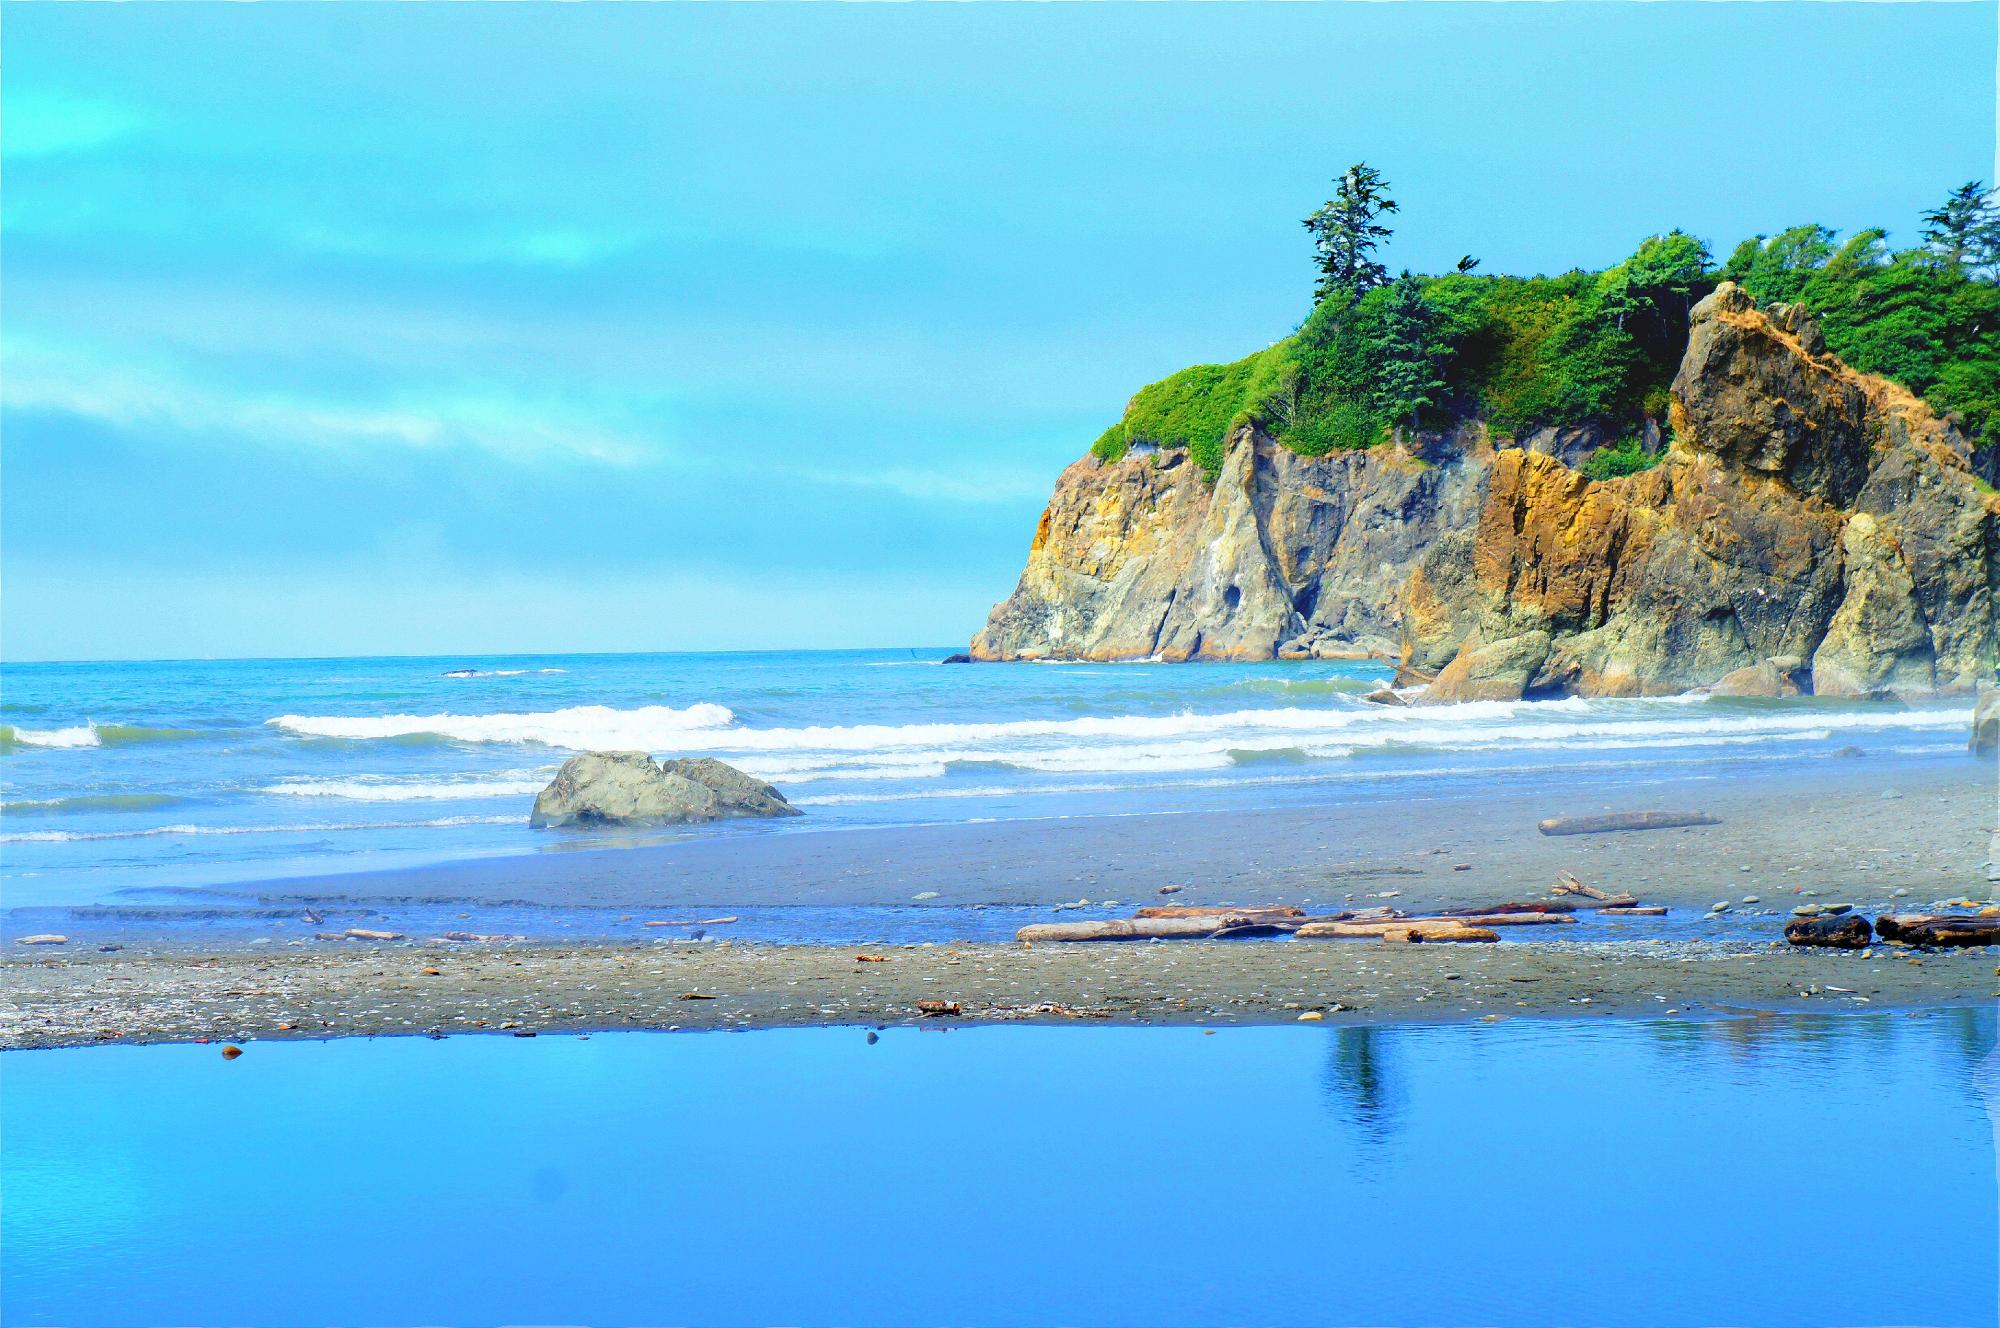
[0,1010,2000,1324]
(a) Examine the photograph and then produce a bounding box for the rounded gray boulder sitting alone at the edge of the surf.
[528,752,798,828]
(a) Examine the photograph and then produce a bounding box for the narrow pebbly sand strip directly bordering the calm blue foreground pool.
[0,940,2000,1050]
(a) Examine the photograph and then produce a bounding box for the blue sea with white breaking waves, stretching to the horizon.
[0,648,1970,906]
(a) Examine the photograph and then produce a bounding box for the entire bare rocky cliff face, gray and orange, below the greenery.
[972,284,2000,700]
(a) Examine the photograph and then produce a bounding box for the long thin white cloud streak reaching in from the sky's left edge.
[0,338,658,466]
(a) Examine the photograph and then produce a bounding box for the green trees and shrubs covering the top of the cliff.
[1092,174,2000,478]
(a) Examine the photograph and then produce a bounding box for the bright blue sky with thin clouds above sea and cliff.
[0,4,1996,658]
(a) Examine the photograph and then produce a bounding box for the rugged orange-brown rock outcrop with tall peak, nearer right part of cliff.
[1404,284,2000,702]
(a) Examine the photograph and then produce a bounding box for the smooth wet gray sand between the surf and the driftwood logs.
[132,756,2000,912]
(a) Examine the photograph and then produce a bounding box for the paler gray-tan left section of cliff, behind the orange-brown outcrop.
[972,428,1480,660]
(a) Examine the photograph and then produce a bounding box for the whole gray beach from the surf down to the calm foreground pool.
[0,758,1996,1046]
